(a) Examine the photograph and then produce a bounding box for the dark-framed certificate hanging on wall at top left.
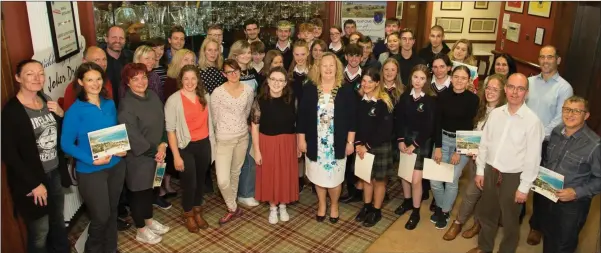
[46,1,80,63]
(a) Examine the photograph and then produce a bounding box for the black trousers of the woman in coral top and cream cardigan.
[179,138,211,212]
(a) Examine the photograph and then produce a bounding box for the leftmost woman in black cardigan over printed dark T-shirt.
[2,60,71,252]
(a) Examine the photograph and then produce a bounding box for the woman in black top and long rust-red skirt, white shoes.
[250,67,300,224]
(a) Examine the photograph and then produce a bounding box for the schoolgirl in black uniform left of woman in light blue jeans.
[394,64,437,230]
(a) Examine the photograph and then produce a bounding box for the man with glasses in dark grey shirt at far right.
[535,96,601,253]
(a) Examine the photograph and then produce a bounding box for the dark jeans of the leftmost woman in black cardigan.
[26,169,70,253]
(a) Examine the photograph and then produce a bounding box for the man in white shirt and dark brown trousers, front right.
[468,73,545,253]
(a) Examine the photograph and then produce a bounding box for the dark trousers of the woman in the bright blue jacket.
[77,158,125,253]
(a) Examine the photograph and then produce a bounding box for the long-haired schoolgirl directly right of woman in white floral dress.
[355,69,394,227]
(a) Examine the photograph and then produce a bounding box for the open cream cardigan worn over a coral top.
[165,90,215,162]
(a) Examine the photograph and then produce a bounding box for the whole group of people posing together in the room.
[2,18,601,253]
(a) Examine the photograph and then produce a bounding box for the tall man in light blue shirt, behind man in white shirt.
[526,45,574,245]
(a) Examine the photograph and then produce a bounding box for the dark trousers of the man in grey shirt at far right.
[536,198,591,253]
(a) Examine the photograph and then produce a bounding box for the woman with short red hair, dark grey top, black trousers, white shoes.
[118,63,169,244]
